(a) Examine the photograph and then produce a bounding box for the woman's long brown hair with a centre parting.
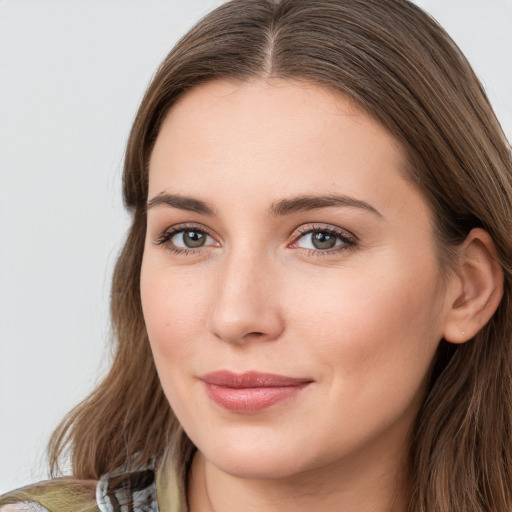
[50,0,512,512]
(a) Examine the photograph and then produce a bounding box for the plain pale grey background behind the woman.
[0,0,512,493]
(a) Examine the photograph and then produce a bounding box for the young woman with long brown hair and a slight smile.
[0,0,512,512]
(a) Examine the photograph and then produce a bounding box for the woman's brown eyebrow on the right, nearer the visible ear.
[269,194,384,218]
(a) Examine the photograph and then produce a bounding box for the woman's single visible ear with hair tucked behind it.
[443,228,503,343]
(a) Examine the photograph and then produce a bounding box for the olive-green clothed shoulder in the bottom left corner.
[0,478,99,512]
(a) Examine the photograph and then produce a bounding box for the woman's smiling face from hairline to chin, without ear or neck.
[141,80,447,477]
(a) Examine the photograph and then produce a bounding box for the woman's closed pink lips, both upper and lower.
[200,370,313,414]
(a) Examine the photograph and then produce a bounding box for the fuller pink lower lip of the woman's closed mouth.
[205,382,309,414]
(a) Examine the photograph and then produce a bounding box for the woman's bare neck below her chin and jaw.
[188,444,407,512]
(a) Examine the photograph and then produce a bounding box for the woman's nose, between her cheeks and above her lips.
[209,250,285,344]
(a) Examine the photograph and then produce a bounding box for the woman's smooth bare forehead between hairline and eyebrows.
[149,80,420,218]
